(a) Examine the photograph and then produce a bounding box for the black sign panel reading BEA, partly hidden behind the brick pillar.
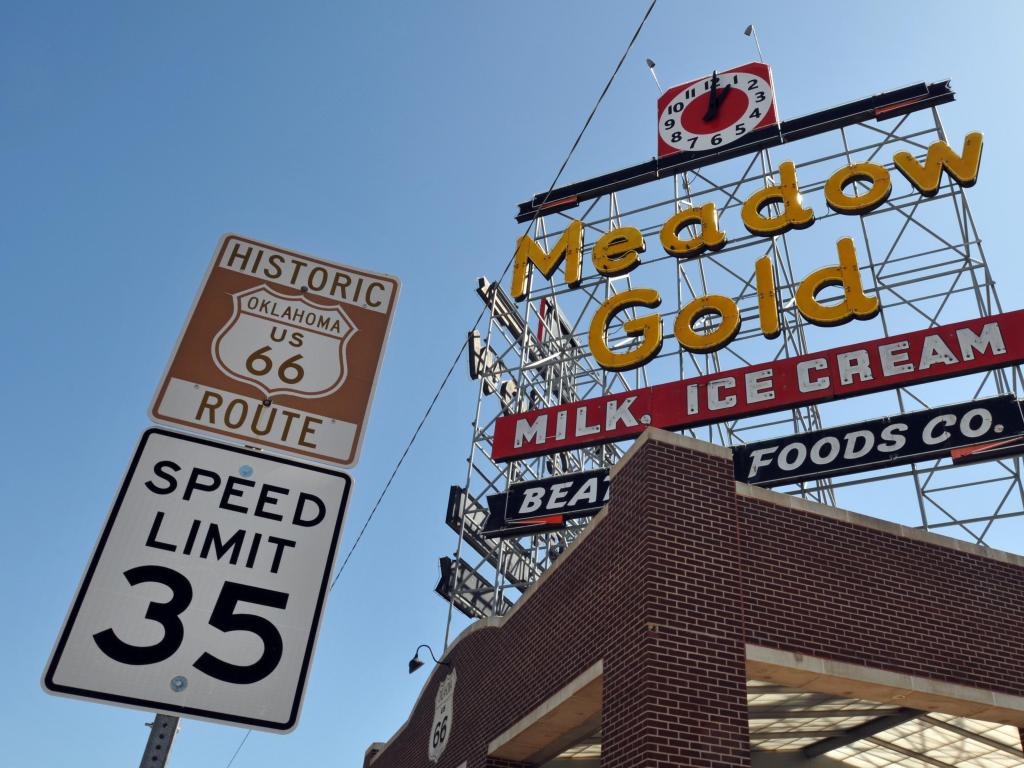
[482,469,608,538]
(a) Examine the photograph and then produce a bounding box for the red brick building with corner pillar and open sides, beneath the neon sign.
[365,430,1024,768]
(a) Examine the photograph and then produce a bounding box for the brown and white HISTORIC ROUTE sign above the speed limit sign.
[151,234,399,466]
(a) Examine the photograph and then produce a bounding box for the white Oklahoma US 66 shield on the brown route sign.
[211,284,357,397]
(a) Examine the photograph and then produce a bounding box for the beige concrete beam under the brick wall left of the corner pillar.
[487,662,604,763]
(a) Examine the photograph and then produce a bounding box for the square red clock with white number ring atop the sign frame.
[657,61,778,158]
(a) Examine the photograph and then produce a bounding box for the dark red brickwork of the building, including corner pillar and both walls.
[372,432,1024,768]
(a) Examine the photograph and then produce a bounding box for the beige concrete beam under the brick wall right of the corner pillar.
[746,645,1024,728]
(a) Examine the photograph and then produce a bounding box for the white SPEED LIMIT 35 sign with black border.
[43,429,351,732]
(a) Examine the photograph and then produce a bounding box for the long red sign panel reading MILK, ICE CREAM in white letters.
[492,310,1024,461]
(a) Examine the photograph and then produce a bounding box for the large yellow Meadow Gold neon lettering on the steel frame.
[512,132,983,371]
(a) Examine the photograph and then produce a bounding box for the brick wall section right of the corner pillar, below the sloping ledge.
[740,499,1024,694]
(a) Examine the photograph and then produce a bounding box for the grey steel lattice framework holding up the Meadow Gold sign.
[437,84,1024,624]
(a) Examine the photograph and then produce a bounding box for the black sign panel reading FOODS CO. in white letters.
[732,394,1024,485]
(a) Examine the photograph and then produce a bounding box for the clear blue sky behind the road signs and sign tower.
[0,0,1024,768]
